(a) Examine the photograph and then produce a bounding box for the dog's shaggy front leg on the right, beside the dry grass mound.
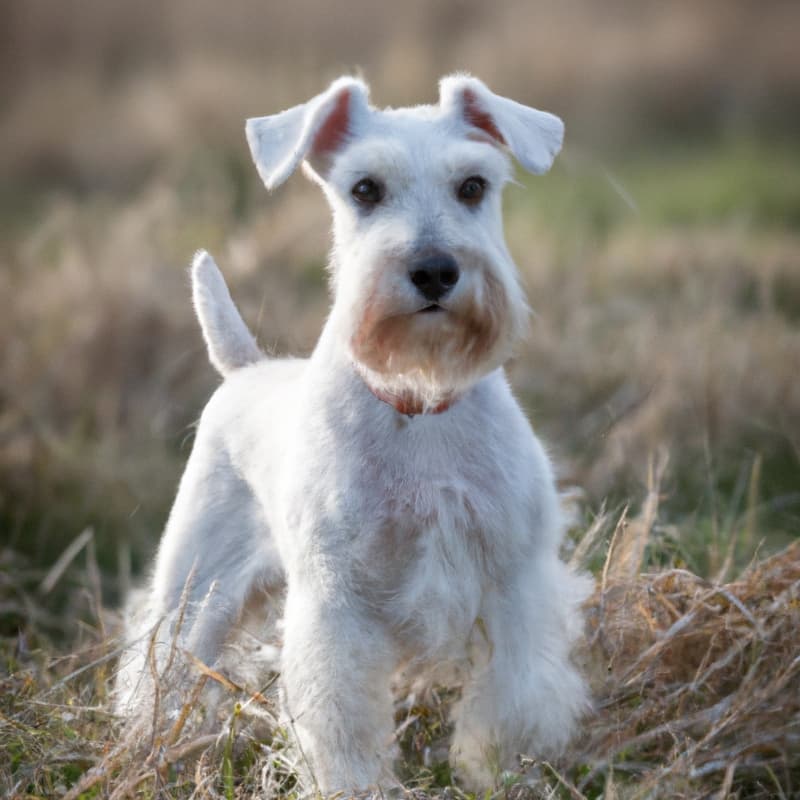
[452,553,591,788]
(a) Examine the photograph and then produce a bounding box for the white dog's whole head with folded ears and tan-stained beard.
[247,75,563,410]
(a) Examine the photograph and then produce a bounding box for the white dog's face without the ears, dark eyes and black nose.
[323,111,527,407]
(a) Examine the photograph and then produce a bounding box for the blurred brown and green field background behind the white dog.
[0,0,800,630]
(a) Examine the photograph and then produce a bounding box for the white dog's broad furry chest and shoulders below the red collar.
[276,377,541,652]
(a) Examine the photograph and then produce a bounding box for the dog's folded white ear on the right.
[439,75,564,175]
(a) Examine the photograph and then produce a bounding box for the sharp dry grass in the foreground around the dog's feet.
[0,504,800,798]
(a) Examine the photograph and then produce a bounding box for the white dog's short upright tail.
[192,250,266,375]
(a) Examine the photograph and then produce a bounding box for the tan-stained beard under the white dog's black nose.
[350,274,524,410]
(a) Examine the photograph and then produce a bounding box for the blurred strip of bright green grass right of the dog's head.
[515,140,800,239]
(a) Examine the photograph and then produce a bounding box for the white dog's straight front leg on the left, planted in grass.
[282,575,393,795]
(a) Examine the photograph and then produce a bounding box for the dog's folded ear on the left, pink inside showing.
[245,77,369,190]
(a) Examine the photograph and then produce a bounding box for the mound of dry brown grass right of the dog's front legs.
[577,543,800,797]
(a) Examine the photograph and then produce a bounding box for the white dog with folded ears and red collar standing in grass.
[118,75,588,793]
